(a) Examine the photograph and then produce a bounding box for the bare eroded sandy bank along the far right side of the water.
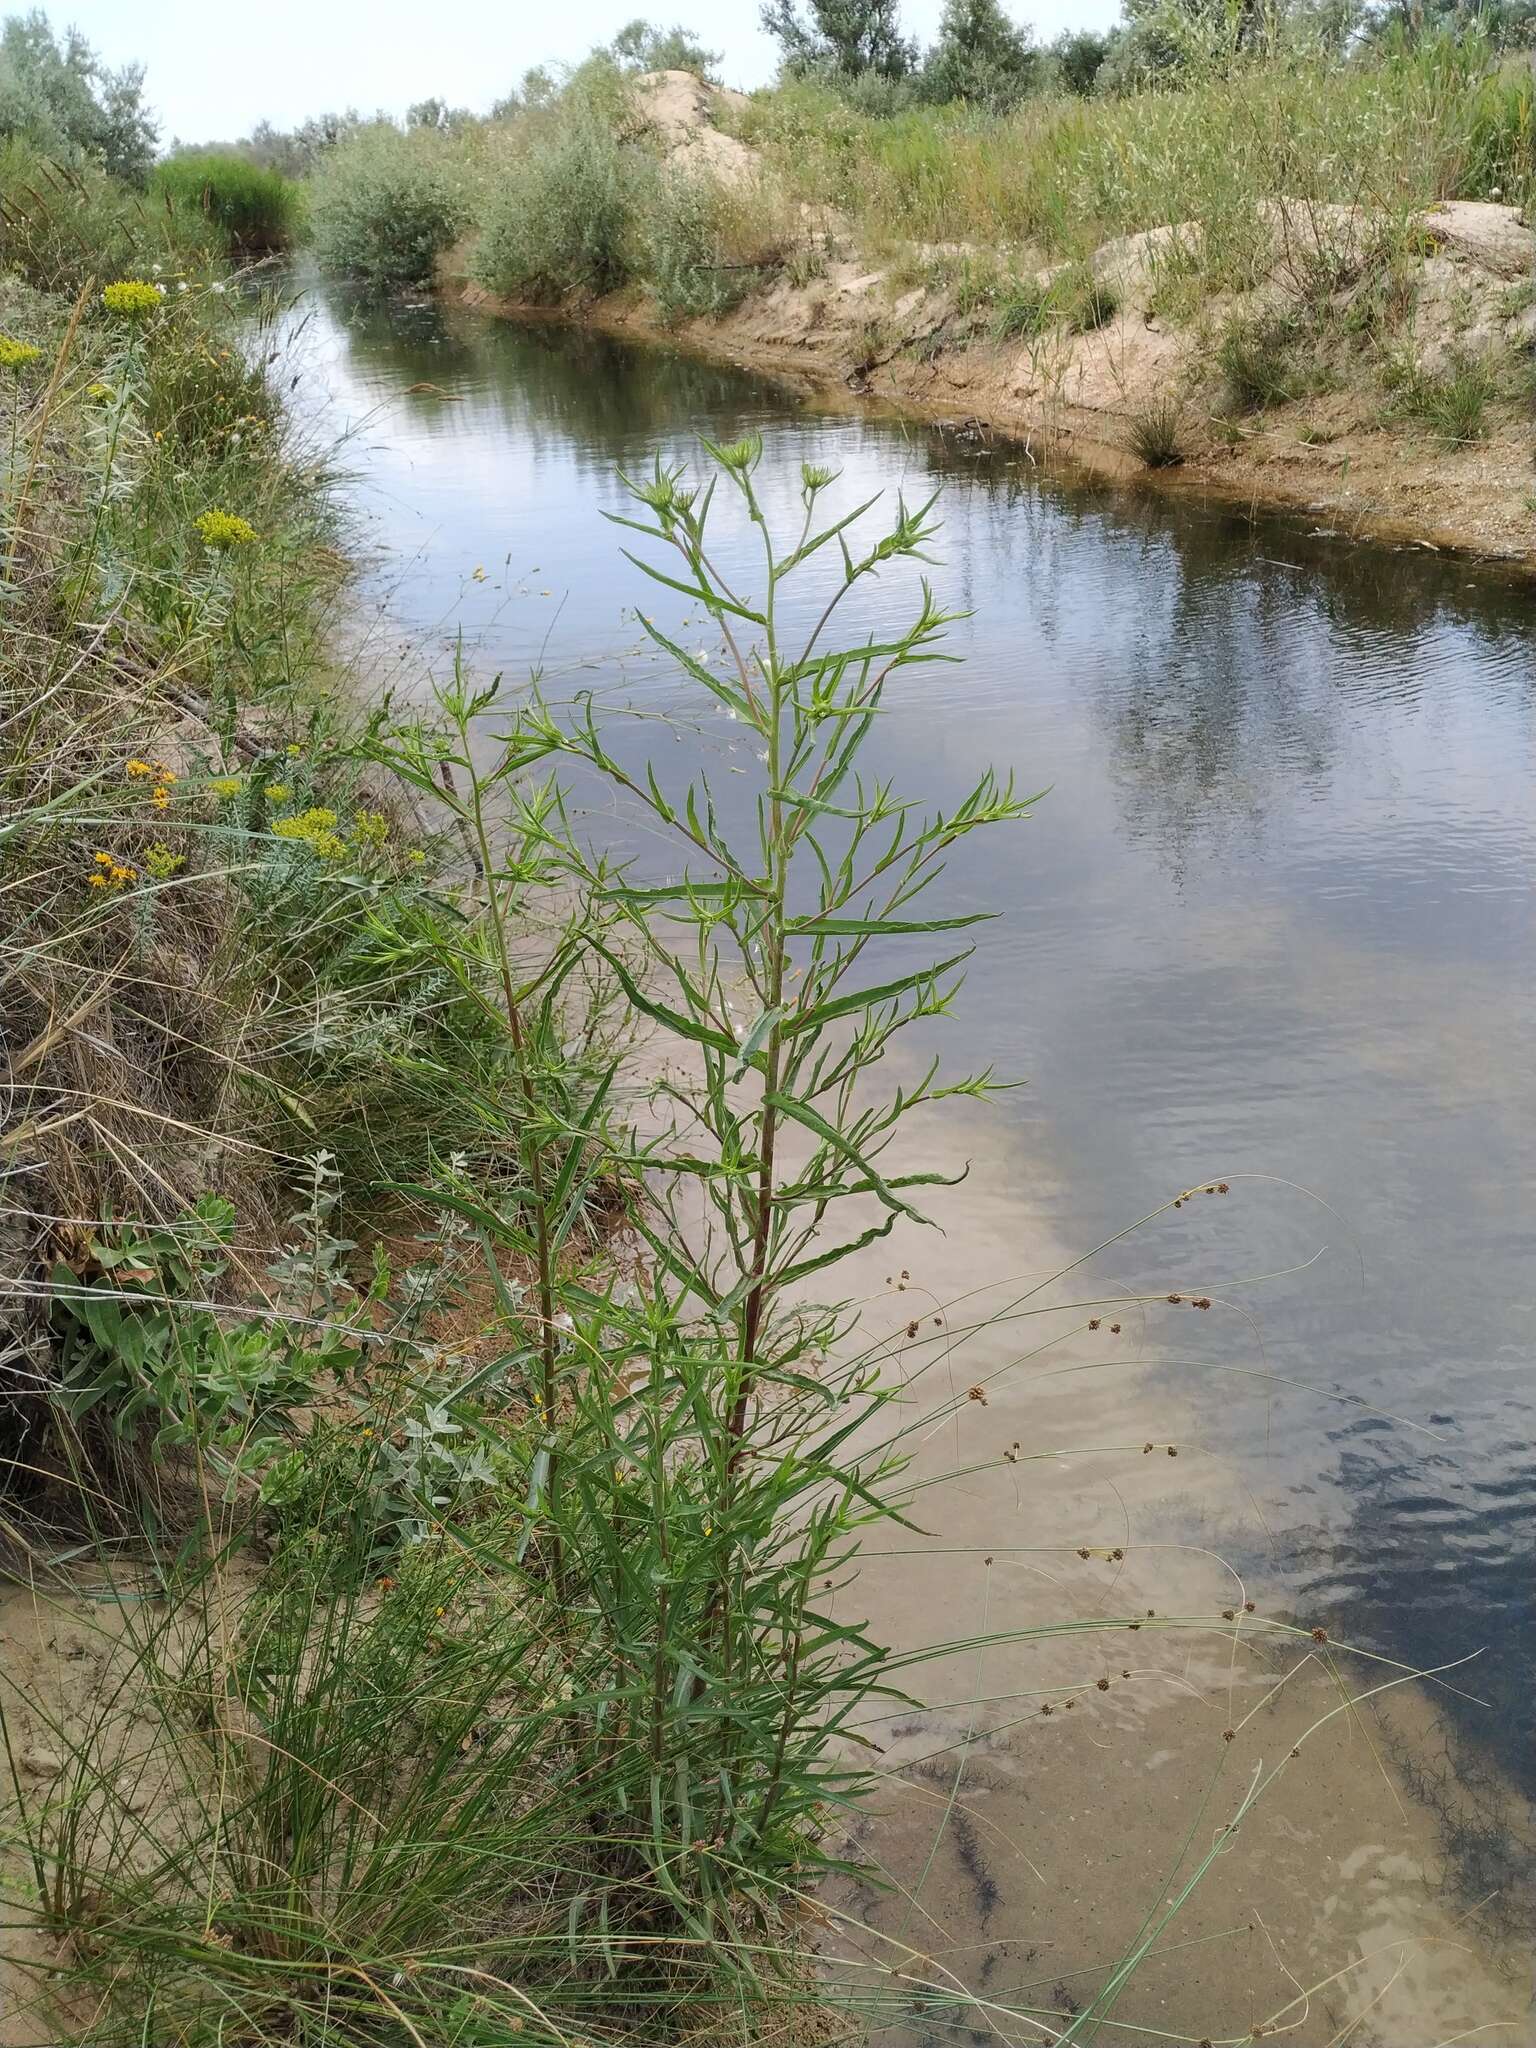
[438,74,1536,571]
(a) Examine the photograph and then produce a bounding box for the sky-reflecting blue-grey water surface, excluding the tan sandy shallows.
[288,284,1536,1786]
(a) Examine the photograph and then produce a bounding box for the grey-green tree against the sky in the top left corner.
[0,8,156,184]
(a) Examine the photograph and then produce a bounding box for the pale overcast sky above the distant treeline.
[51,0,1118,143]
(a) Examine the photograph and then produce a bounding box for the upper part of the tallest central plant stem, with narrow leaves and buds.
[557,436,1034,1392]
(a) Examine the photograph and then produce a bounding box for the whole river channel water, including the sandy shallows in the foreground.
[289,293,1536,2048]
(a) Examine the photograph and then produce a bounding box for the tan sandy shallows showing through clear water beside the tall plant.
[823,1120,1536,2048]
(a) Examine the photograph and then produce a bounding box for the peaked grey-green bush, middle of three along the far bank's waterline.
[473,104,651,301]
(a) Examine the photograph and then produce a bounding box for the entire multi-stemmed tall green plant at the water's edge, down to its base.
[358,438,1028,1939]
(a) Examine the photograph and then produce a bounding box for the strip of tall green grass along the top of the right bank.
[743,37,1536,266]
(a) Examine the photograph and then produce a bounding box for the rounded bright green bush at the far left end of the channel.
[309,123,469,285]
